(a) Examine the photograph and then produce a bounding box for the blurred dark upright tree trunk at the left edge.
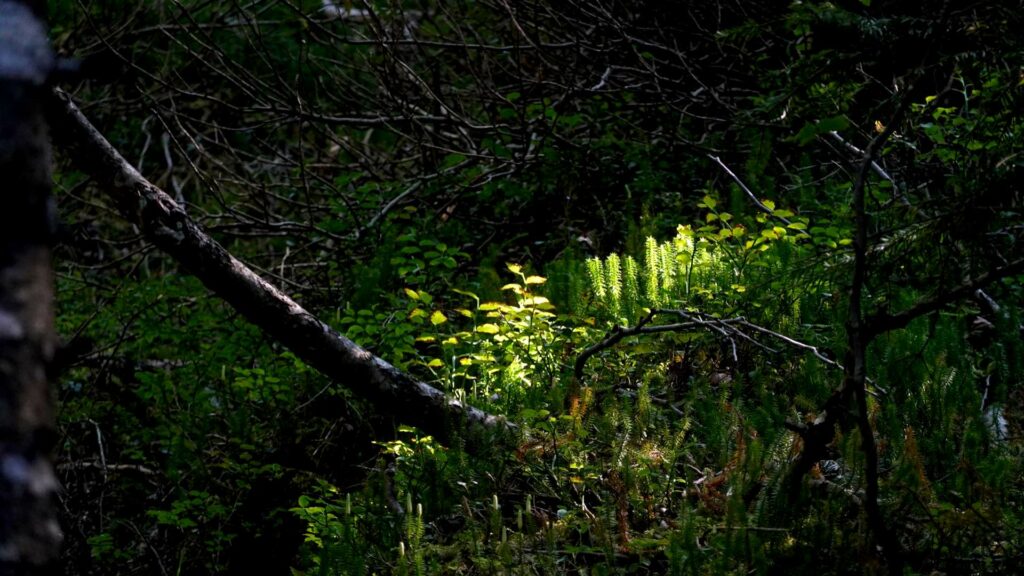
[0,0,61,575]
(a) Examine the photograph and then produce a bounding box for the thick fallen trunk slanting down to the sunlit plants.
[49,89,515,451]
